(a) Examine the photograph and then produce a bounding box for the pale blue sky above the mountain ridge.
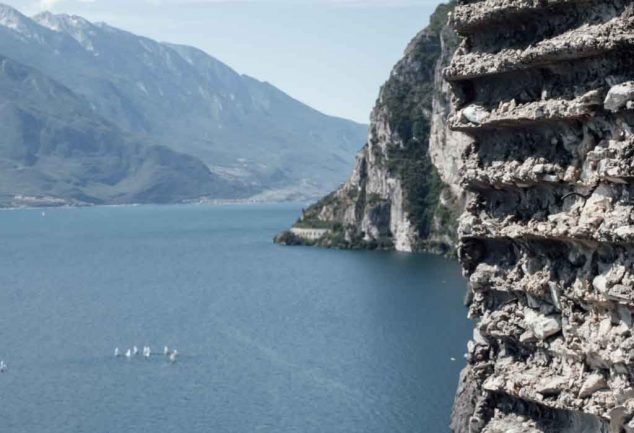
[0,0,440,123]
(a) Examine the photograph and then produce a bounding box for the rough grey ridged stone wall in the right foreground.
[444,0,634,433]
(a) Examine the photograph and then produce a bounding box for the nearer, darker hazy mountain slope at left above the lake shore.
[0,56,246,206]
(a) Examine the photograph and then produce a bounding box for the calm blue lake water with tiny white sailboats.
[0,205,471,433]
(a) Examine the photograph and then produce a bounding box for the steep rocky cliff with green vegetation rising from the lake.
[277,3,468,253]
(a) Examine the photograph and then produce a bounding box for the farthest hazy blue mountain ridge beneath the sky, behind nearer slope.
[0,5,367,197]
